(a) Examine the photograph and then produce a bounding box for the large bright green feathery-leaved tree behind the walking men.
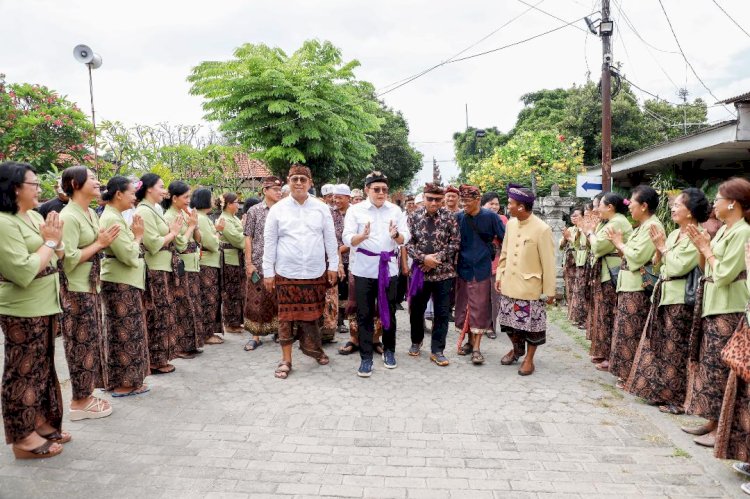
[188,40,380,181]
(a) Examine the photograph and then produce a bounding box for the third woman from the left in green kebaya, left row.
[99,175,149,397]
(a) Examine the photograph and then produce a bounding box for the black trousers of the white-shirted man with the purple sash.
[354,275,398,359]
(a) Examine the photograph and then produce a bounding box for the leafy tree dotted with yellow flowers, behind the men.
[468,130,585,206]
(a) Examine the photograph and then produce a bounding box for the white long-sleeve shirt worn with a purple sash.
[342,199,410,279]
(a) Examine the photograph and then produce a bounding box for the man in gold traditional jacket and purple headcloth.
[495,184,556,376]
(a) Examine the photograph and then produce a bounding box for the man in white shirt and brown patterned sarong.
[263,165,339,379]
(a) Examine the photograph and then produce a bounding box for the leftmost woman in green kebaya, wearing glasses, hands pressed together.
[0,162,66,459]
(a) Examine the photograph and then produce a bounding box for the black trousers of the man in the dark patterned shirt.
[409,279,453,353]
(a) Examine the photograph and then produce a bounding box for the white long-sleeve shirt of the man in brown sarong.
[263,196,339,279]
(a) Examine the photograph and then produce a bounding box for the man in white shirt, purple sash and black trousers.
[343,172,409,378]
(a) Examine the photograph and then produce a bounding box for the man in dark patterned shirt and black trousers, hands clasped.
[406,184,461,366]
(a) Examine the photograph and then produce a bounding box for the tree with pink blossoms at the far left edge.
[0,74,93,172]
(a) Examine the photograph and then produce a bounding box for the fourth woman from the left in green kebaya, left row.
[135,173,184,374]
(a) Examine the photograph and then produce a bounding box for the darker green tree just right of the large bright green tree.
[368,102,422,190]
